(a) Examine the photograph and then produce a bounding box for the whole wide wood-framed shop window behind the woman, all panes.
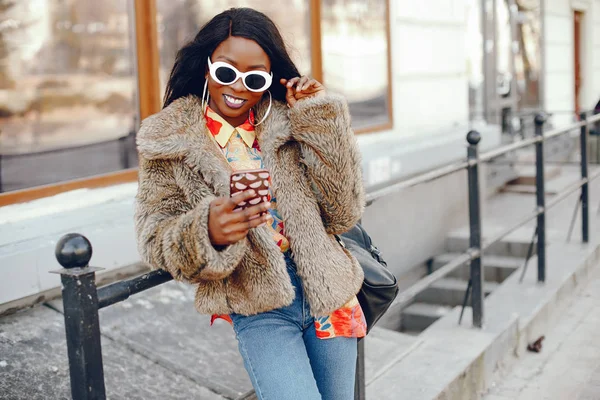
[0,0,392,200]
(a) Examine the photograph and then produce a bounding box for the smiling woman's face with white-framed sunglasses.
[206,36,271,126]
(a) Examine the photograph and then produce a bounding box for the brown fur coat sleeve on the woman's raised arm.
[289,94,365,234]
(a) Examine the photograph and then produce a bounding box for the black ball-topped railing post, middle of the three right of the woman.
[534,114,546,282]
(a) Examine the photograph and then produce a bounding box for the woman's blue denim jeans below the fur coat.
[231,256,356,400]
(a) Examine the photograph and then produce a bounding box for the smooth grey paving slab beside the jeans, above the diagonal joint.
[53,281,252,398]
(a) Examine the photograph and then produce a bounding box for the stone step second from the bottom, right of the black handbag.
[415,278,500,306]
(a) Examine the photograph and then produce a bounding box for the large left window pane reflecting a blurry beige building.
[0,0,136,192]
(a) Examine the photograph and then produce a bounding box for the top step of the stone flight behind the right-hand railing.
[446,226,536,258]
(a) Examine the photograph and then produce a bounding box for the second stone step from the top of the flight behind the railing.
[432,253,525,282]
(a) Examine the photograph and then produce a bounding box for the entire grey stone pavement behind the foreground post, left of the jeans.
[0,282,239,400]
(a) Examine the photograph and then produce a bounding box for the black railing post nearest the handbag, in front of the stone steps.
[467,131,484,328]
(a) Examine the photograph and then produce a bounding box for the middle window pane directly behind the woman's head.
[157,0,311,101]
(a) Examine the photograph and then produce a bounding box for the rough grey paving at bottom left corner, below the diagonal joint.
[0,306,224,400]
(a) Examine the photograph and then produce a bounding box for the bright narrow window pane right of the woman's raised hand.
[321,0,391,129]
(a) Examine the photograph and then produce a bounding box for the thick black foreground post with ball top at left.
[53,233,106,400]
